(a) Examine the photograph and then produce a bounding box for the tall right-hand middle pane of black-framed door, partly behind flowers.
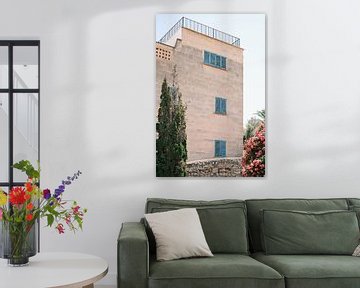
[13,93,39,182]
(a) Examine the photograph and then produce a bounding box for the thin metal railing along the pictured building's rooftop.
[159,17,240,47]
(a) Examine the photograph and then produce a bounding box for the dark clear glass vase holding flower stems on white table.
[0,221,37,266]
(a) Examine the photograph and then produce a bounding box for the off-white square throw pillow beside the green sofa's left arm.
[145,208,213,261]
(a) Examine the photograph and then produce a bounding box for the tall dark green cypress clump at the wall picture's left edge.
[156,67,187,177]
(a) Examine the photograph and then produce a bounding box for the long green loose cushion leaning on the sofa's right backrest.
[262,210,360,255]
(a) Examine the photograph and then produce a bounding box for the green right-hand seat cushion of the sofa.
[252,253,360,288]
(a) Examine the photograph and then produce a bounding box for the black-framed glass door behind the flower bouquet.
[0,40,40,251]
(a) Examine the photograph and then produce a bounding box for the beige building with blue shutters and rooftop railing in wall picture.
[156,18,243,162]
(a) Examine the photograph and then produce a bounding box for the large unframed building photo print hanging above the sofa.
[155,14,265,177]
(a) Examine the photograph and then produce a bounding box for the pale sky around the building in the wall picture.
[156,14,266,126]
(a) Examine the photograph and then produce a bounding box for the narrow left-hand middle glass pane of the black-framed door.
[0,93,9,182]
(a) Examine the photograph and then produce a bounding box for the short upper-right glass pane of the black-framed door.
[13,46,39,89]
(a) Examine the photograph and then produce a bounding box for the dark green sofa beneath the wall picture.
[117,198,360,288]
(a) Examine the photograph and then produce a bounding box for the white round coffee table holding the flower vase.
[0,252,108,288]
